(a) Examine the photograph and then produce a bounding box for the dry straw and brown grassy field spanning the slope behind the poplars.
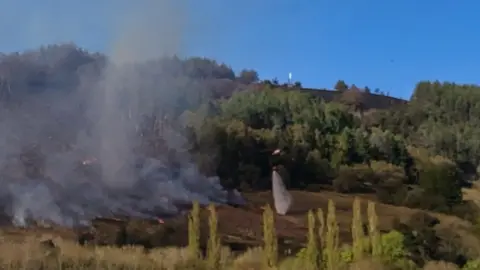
[0,191,480,270]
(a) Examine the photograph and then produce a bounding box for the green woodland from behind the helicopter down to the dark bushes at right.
[182,82,462,215]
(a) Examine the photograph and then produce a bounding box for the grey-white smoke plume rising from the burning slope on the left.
[0,1,242,225]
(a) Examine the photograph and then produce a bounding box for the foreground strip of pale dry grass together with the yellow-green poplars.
[0,198,480,270]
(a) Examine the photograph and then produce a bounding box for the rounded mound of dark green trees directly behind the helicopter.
[190,88,416,192]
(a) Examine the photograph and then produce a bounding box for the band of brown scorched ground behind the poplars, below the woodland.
[1,191,479,258]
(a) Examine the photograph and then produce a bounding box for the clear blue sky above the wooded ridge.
[0,0,480,98]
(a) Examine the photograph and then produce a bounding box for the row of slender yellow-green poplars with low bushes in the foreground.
[187,198,480,270]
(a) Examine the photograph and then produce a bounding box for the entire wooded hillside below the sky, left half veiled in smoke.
[0,44,480,266]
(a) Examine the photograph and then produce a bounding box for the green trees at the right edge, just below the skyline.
[371,81,480,177]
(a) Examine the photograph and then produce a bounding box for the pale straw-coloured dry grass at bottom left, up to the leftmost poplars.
[0,237,233,270]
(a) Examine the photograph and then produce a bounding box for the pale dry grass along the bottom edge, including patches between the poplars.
[0,237,390,270]
